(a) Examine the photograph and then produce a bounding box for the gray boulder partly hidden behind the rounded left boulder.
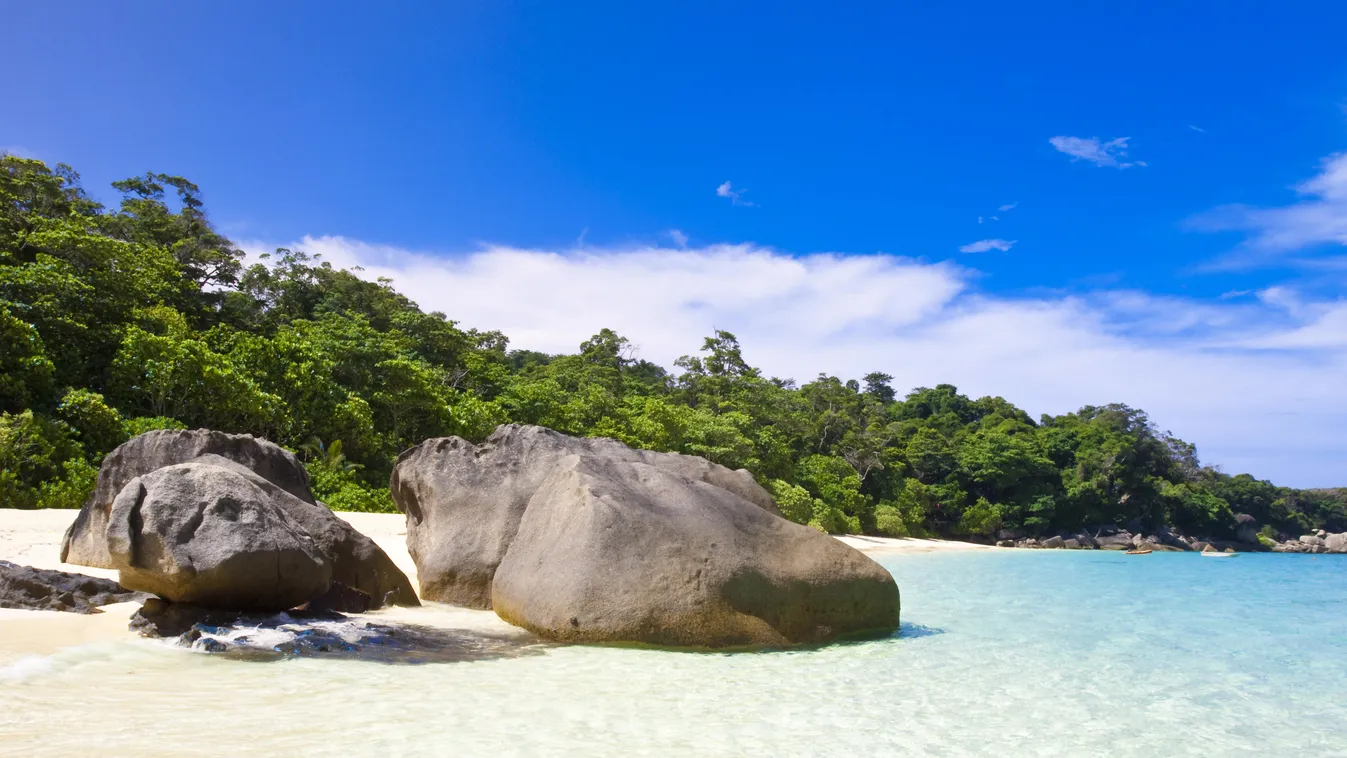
[61,429,315,568]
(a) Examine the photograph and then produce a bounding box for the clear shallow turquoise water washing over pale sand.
[0,551,1347,757]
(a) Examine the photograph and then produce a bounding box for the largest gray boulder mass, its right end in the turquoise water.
[392,425,898,648]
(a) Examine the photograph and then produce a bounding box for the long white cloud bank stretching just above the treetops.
[239,237,1347,486]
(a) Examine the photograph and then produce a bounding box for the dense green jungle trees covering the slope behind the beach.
[0,155,1347,537]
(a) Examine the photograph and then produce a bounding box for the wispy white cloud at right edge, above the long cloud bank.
[1191,152,1347,261]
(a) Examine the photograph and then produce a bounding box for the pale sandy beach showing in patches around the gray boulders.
[0,508,995,665]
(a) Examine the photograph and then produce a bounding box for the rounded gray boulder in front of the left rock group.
[106,463,333,611]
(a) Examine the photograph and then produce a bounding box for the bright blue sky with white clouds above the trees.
[0,1,1347,485]
